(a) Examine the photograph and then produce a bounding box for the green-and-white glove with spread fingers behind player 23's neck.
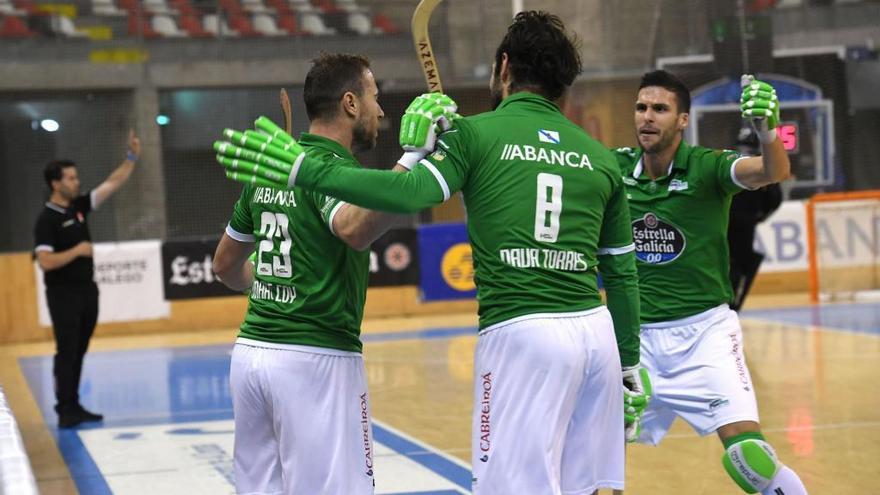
[214,117,306,189]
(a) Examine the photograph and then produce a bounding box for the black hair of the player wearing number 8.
[495,10,582,100]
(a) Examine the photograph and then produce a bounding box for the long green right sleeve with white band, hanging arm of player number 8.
[599,178,639,366]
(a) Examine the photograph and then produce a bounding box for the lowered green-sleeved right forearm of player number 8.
[599,252,640,366]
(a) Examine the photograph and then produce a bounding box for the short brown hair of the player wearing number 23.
[303,53,370,120]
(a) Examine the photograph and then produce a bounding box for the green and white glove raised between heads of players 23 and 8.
[400,93,460,154]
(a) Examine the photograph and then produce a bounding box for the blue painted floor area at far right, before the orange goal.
[741,303,880,335]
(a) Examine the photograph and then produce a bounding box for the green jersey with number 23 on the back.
[226,134,370,352]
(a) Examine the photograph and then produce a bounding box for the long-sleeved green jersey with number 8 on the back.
[296,92,638,365]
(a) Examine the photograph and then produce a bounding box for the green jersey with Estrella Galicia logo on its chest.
[615,141,744,323]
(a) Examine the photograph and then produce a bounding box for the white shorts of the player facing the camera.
[639,304,758,445]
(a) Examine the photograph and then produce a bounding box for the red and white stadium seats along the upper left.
[0,0,400,39]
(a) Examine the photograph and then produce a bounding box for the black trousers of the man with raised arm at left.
[46,282,98,414]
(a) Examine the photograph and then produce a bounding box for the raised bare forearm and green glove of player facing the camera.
[735,76,791,189]
